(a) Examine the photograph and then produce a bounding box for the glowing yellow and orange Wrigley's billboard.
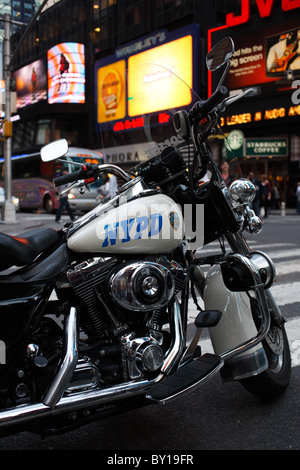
[95,25,200,131]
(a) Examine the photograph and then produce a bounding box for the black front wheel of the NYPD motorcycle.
[240,318,291,400]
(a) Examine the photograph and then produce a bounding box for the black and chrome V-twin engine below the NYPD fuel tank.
[57,257,186,393]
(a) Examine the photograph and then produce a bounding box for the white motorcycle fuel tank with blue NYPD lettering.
[68,193,184,254]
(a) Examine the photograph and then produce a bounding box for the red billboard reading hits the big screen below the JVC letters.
[208,18,300,96]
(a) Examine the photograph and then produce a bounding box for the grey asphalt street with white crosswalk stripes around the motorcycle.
[0,213,300,455]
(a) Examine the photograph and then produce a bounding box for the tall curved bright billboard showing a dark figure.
[47,42,85,104]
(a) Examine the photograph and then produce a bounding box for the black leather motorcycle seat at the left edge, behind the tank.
[0,227,59,271]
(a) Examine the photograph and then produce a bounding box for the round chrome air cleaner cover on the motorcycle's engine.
[109,261,175,311]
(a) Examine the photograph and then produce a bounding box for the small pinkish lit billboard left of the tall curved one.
[13,60,47,109]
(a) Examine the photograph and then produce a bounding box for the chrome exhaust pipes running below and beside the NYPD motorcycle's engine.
[0,301,182,428]
